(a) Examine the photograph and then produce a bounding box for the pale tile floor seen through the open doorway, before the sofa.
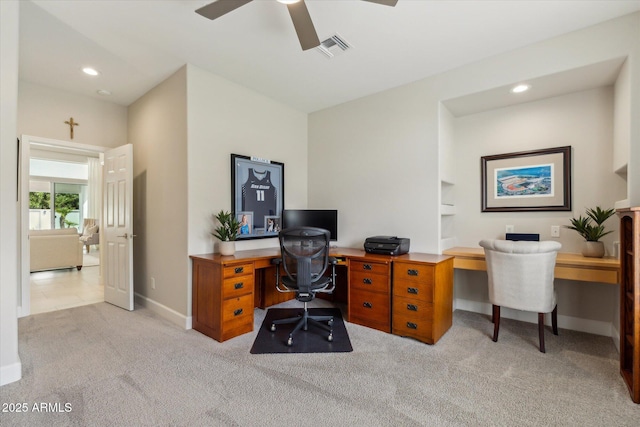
[31,251,104,314]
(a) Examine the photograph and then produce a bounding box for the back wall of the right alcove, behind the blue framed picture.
[454,86,626,335]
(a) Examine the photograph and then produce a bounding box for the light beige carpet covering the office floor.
[0,301,640,427]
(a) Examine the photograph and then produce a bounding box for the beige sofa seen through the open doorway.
[29,228,83,271]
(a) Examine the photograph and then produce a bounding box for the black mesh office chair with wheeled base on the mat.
[271,227,337,346]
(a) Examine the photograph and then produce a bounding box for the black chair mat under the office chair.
[251,308,353,354]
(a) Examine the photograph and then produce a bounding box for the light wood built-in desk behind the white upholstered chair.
[443,247,620,285]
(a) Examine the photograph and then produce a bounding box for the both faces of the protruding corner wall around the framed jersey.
[129,65,307,327]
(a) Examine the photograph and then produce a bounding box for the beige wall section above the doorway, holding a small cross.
[18,81,127,148]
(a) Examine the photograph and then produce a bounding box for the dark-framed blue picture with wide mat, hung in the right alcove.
[480,146,571,212]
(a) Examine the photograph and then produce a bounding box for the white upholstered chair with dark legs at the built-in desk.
[480,240,562,353]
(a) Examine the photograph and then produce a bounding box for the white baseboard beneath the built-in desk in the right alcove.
[454,299,620,340]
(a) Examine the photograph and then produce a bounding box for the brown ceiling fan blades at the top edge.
[196,0,398,50]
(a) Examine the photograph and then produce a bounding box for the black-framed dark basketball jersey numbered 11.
[231,154,284,240]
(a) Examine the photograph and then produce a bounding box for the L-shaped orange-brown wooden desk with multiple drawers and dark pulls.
[190,248,453,344]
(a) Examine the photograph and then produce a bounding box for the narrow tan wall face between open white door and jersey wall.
[129,67,189,316]
